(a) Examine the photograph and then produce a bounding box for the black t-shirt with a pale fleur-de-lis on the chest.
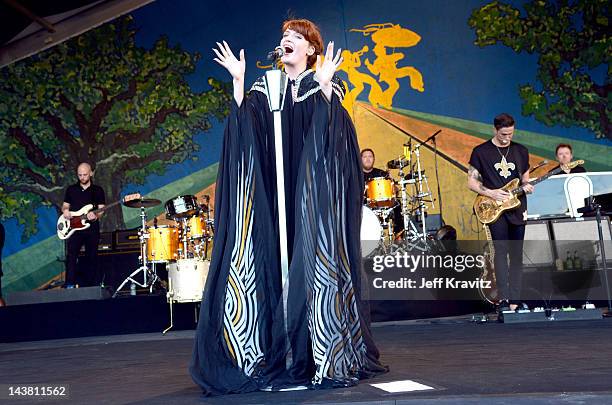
[470,140,529,225]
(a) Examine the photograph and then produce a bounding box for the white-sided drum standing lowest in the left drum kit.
[167,259,210,302]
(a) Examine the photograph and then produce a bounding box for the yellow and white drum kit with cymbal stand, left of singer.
[114,195,214,310]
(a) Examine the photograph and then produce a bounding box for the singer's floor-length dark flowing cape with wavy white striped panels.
[190,70,386,395]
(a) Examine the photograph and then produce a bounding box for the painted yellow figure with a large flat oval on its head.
[351,23,425,108]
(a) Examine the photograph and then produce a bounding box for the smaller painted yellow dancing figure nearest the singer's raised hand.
[338,45,383,114]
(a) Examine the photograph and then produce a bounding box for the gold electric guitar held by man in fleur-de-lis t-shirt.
[474,160,584,224]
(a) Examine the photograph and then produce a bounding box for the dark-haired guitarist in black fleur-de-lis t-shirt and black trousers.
[467,113,533,311]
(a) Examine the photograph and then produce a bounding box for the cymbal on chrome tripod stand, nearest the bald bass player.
[113,198,161,298]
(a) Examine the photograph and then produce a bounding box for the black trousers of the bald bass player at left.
[66,230,100,285]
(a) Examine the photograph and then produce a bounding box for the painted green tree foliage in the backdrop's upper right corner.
[468,0,612,139]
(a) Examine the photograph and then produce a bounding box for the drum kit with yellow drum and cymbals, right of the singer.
[361,137,435,256]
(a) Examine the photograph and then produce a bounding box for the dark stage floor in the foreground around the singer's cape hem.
[0,317,612,405]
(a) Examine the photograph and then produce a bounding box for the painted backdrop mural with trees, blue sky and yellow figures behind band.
[0,0,612,292]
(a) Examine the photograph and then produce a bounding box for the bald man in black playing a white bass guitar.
[62,163,106,288]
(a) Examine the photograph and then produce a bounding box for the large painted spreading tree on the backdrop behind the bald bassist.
[0,17,230,240]
